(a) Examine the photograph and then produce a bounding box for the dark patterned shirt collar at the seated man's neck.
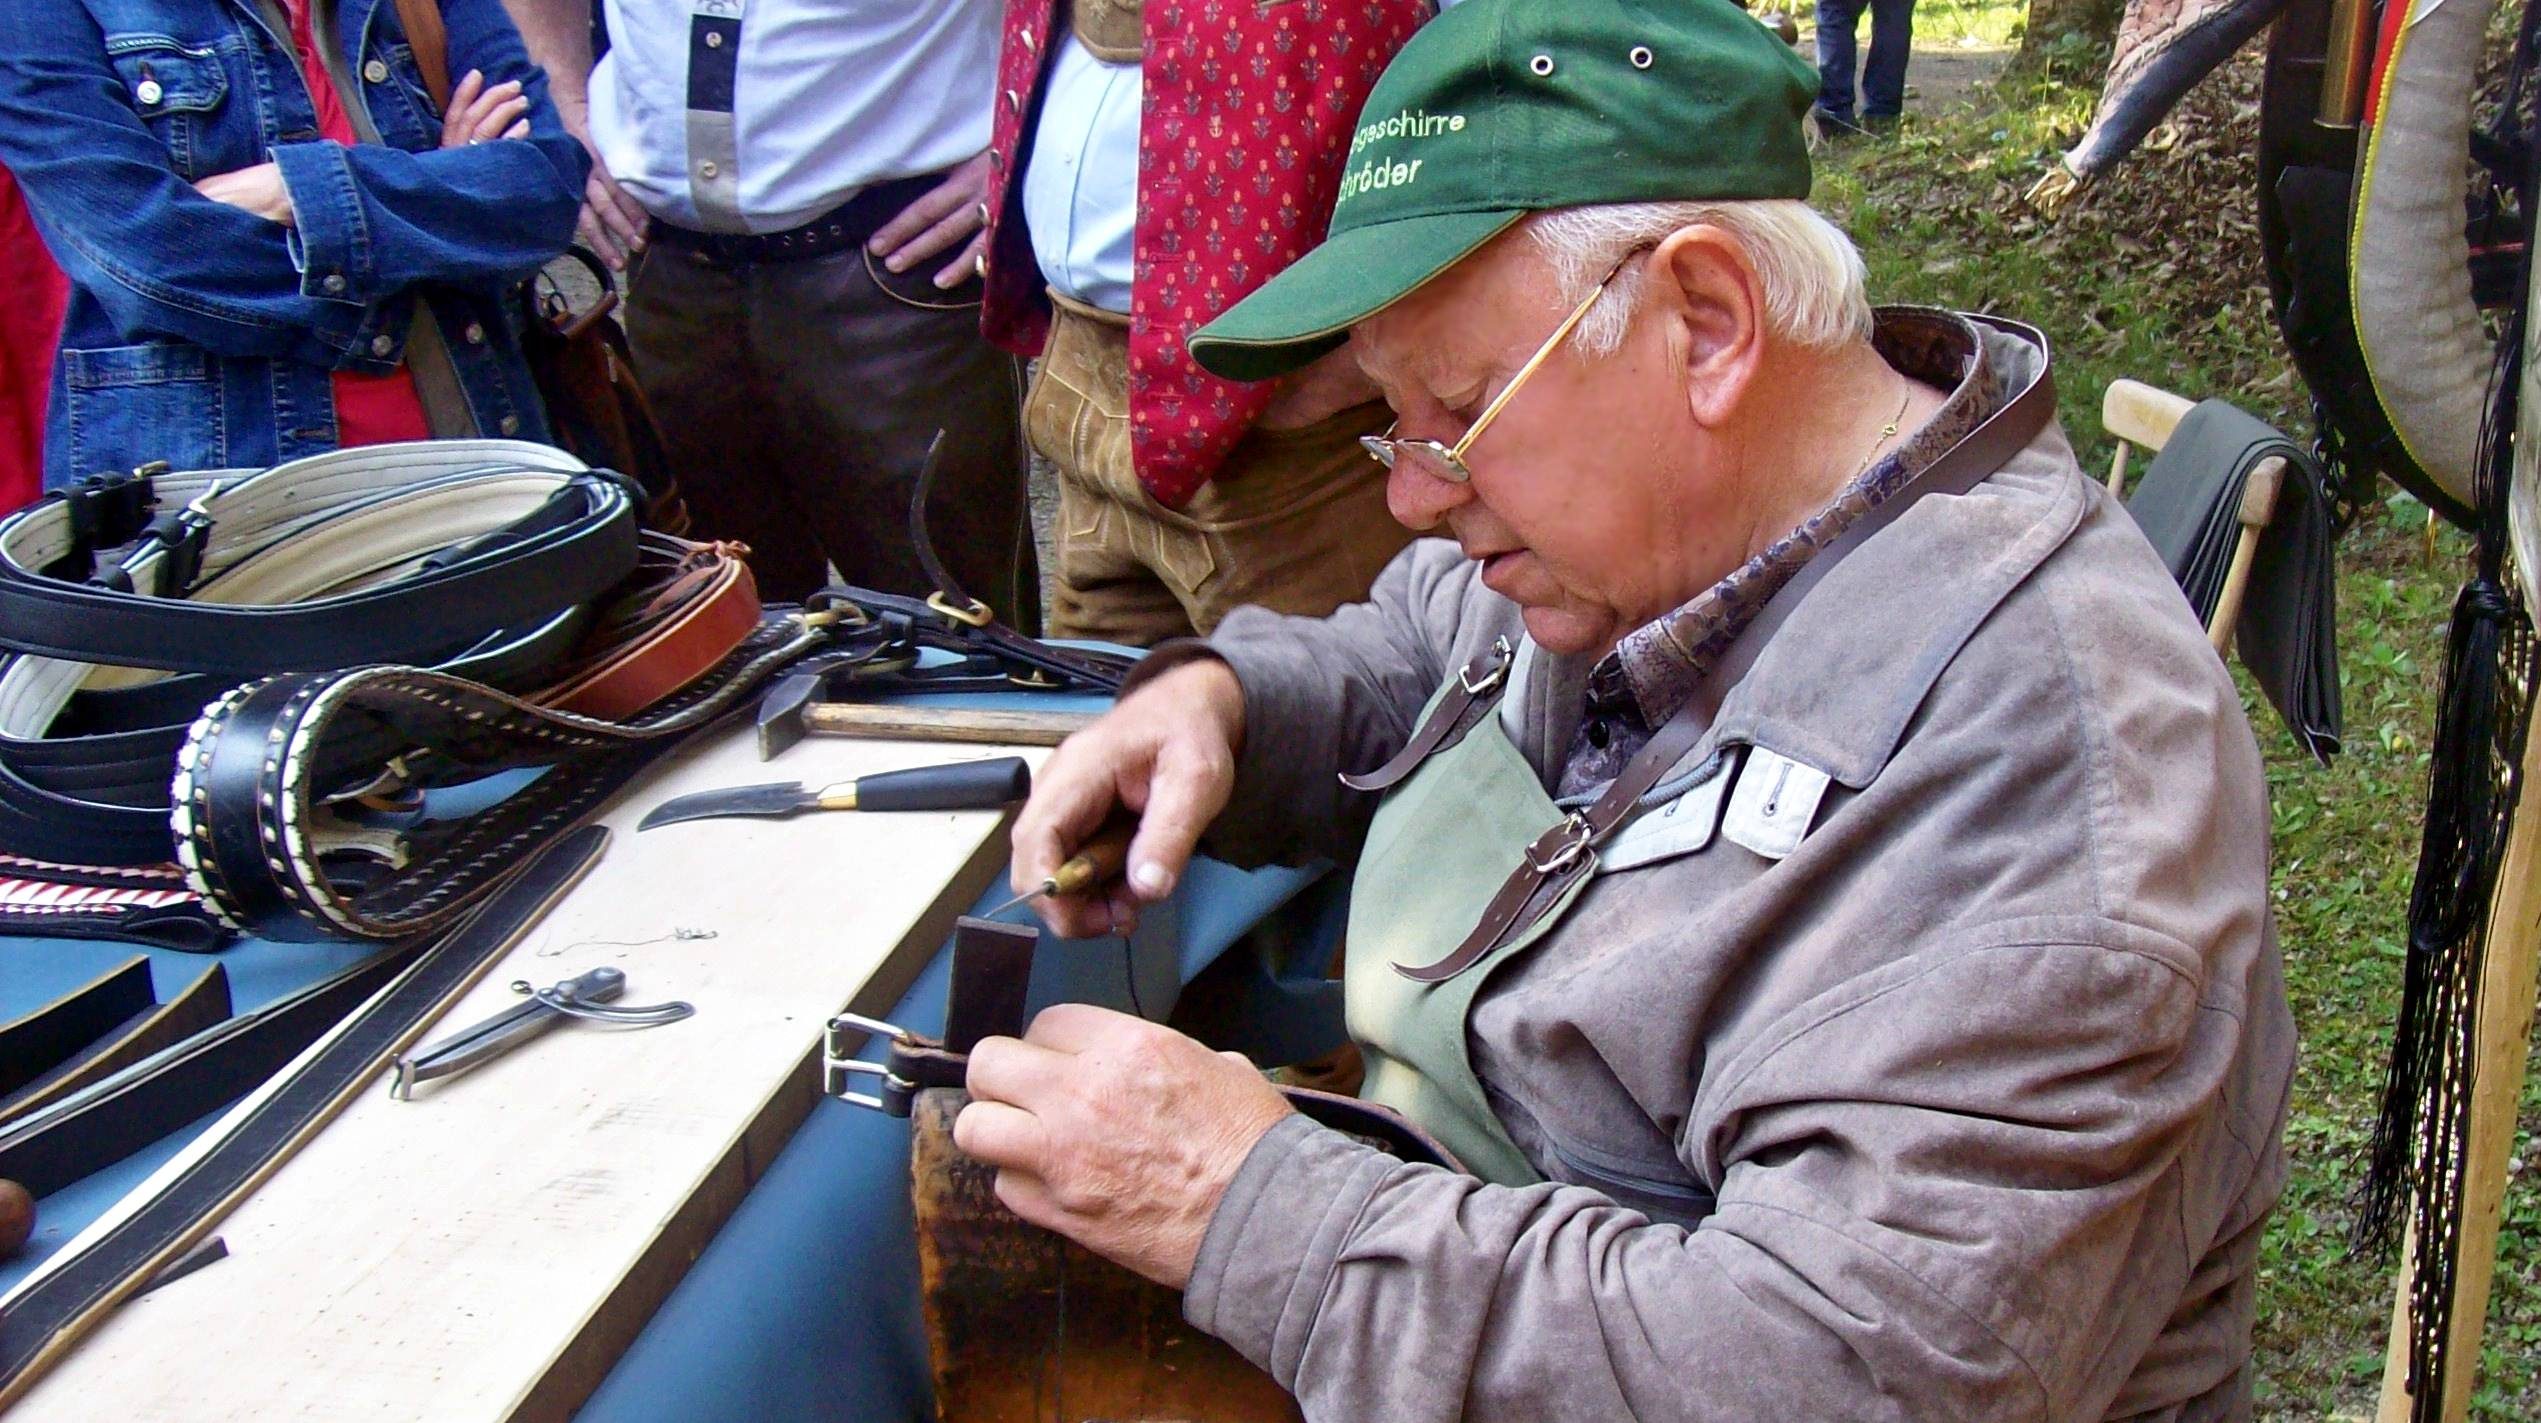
[1555,307,2005,803]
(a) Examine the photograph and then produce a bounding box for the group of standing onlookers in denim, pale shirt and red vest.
[0,0,1504,645]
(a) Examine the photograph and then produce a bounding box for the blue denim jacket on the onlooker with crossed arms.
[0,0,590,485]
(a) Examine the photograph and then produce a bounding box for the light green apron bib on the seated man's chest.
[1344,660,1591,1184]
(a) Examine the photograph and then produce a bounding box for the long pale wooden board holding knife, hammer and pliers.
[10,729,1042,1423]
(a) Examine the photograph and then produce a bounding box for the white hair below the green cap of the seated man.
[1527,198,1870,356]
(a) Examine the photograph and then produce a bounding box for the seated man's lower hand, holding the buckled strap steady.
[953,1004,1291,1288]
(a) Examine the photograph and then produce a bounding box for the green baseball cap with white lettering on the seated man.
[1192,0,1817,381]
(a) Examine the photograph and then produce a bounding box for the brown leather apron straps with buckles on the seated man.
[1382,318,2056,983]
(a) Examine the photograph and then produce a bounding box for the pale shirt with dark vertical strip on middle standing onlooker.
[592,0,996,231]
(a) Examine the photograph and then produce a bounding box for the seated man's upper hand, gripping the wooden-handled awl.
[1014,658,1245,938]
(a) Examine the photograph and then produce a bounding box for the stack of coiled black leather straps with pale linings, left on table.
[0,440,635,864]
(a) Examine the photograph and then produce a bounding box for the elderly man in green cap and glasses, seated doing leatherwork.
[955,0,2292,1420]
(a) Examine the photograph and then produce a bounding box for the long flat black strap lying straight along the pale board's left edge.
[0,826,607,1408]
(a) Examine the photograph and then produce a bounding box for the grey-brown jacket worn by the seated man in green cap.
[1166,404,2295,1423]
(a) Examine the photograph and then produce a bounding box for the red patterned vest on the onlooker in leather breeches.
[981,0,1431,508]
